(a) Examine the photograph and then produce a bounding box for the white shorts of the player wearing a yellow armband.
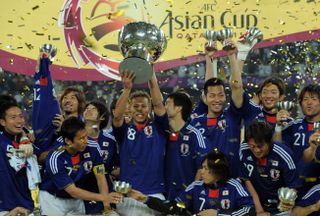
[39,190,85,216]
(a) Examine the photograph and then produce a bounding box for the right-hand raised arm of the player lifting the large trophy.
[148,73,166,116]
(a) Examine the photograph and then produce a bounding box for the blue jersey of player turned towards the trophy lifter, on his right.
[165,123,205,200]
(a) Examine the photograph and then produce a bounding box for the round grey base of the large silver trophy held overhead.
[119,57,153,84]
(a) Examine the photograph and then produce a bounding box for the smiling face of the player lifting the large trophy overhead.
[130,96,151,123]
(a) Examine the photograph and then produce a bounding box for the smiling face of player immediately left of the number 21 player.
[259,83,283,111]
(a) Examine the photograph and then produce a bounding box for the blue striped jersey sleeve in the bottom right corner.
[296,184,320,216]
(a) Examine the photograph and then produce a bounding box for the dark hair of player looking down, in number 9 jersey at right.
[245,119,273,146]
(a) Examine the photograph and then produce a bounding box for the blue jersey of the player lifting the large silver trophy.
[113,115,169,194]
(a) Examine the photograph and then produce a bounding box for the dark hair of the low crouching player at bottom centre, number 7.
[202,148,231,184]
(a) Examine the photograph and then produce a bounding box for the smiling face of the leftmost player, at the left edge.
[0,106,25,135]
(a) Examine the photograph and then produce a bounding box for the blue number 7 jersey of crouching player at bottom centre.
[175,179,253,215]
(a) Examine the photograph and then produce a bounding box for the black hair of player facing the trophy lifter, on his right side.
[168,91,192,121]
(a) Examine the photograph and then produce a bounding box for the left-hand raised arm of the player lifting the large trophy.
[112,71,135,127]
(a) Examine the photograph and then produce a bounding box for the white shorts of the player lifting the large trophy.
[117,193,165,216]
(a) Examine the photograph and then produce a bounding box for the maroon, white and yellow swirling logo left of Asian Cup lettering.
[59,0,135,80]
